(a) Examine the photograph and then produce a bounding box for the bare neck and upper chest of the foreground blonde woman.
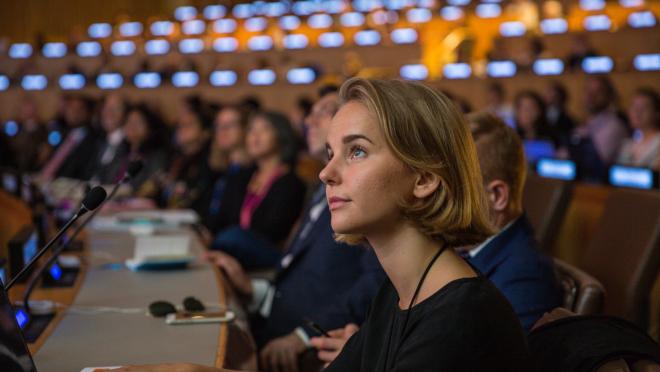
[367,224,475,309]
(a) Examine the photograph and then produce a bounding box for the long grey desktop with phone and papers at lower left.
[23,228,255,372]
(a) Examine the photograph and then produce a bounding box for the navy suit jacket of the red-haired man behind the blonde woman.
[468,215,561,332]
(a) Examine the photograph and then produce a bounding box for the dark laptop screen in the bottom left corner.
[0,286,37,372]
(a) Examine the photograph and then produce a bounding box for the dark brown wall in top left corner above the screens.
[0,0,219,42]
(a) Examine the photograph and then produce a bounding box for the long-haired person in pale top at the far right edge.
[617,88,660,171]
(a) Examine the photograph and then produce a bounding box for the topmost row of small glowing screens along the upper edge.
[168,0,644,22]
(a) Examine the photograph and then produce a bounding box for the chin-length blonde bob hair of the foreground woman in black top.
[336,78,494,247]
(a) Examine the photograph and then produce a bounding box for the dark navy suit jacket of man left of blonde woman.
[252,187,385,347]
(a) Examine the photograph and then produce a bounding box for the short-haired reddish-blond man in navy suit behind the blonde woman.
[467,113,561,331]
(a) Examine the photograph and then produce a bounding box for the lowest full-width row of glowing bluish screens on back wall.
[0,53,660,91]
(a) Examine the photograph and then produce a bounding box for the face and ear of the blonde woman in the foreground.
[320,102,415,237]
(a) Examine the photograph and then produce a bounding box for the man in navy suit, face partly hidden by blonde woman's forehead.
[207,88,384,371]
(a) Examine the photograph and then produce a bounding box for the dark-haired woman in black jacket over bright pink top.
[210,112,305,268]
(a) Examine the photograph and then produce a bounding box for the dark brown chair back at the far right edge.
[581,189,660,329]
